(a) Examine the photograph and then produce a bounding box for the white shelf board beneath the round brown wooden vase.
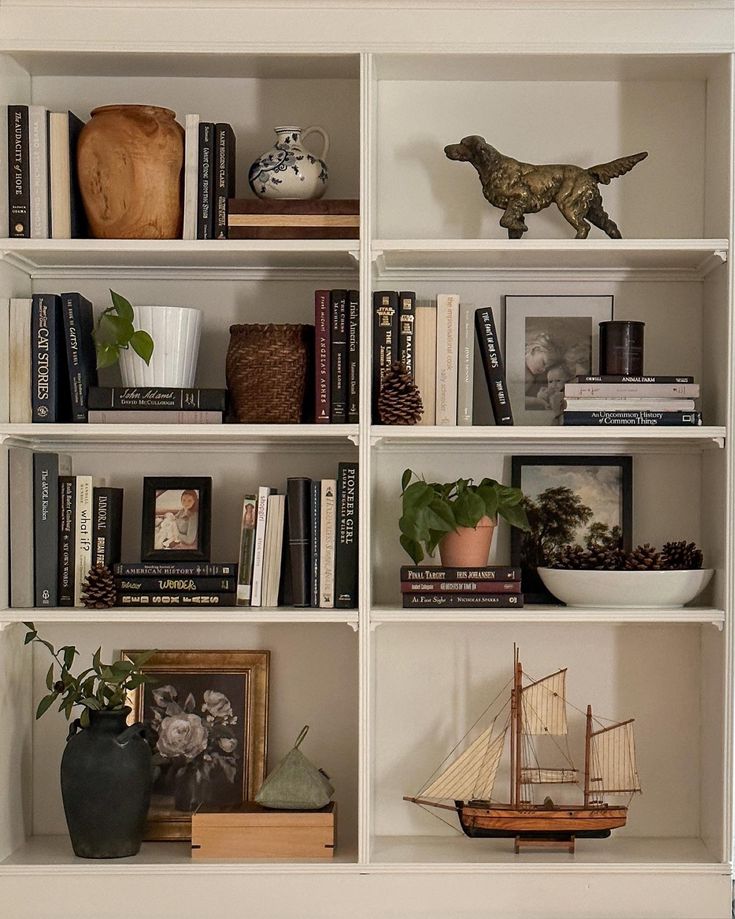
[0,239,359,278]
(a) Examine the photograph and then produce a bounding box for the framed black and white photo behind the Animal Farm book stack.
[504,295,613,424]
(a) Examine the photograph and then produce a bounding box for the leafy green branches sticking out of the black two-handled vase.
[23,622,156,727]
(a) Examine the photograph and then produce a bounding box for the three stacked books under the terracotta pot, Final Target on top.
[401,565,523,609]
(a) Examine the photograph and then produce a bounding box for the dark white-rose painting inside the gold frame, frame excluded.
[144,673,247,813]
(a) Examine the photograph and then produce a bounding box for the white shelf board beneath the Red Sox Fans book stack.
[0,606,358,628]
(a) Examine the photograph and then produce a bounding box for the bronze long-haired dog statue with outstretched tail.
[444,134,648,239]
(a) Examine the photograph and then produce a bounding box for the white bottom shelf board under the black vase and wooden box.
[0,836,357,878]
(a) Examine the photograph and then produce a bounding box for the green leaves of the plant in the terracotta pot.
[398,469,529,565]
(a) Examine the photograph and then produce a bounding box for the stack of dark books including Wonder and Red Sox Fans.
[113,561,237,607]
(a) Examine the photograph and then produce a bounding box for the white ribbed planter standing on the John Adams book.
[120,306,202,388]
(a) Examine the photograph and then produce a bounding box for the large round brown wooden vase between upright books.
[77,105,184,239]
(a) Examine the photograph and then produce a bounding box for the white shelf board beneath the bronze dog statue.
[372,239,728,280]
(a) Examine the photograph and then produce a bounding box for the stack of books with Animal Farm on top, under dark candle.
[562,376,702,427]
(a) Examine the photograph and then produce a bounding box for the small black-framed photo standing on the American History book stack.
[140,476,212,562]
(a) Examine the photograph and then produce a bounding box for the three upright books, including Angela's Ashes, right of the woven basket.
[314,290,360,424]
